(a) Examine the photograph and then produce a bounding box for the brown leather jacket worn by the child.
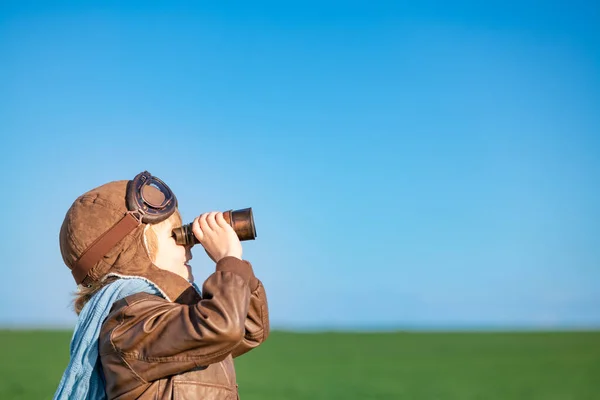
[100,257,269,400]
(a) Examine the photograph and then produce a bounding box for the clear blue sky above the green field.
[0,0,600,329]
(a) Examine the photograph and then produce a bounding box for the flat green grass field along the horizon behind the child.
[0,331,600,400]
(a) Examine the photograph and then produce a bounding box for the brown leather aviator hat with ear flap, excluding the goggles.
[59,181,191,301]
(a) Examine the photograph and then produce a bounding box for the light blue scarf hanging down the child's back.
[54,278,161,400]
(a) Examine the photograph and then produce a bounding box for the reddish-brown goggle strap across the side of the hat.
[71,211,142,285]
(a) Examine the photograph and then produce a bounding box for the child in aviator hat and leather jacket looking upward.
[54,172,269,400]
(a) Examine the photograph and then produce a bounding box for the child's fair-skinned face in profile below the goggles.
[152,219,194,282]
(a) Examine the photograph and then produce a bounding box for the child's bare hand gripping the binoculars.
[192,211,242,262]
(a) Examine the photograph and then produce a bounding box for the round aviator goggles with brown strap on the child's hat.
[71,171,177,285]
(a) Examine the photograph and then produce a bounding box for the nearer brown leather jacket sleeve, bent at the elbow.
[110,257,256,382]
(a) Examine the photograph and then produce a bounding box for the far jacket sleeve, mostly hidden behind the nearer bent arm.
[231,278,270,357]
